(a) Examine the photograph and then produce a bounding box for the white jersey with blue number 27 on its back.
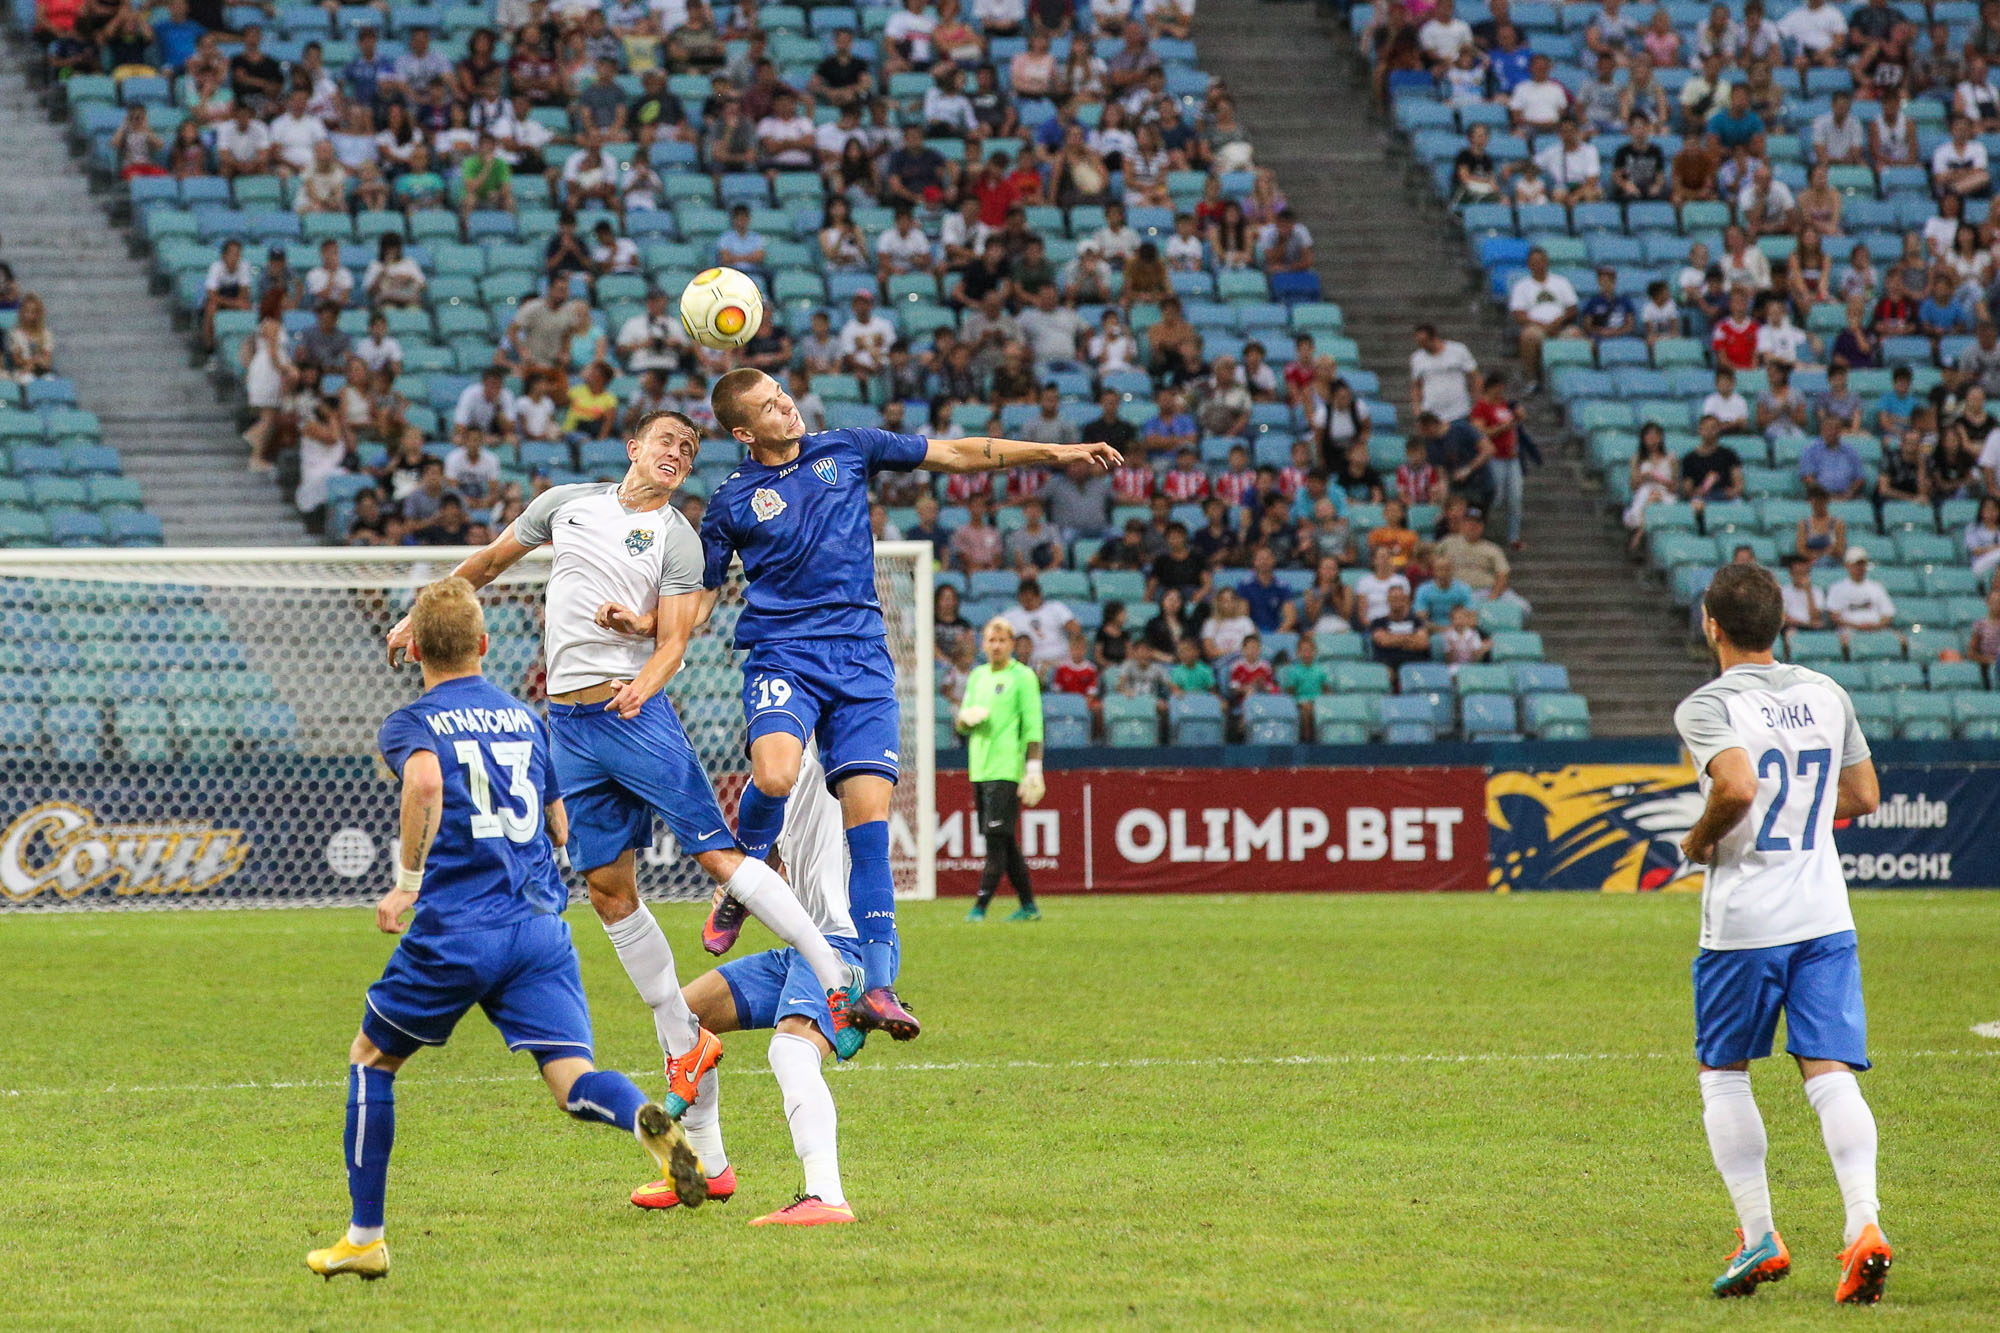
[1674,662,1868,949]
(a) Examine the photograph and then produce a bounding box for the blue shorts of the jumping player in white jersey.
[548,695,736,871]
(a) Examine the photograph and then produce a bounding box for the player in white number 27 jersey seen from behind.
[1674,564,1892,1305]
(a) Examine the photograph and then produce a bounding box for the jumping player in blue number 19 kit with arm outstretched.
[702,366,1122,1041]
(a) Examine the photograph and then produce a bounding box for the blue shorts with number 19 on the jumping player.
[744,638,902,791]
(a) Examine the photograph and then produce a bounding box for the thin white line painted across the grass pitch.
[0,1047,2000,1097]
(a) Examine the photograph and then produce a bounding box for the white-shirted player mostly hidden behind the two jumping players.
[632,743,862,1227]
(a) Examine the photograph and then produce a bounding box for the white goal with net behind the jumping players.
[0,542,936,909]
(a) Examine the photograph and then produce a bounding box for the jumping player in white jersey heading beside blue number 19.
[388,412,860,1144]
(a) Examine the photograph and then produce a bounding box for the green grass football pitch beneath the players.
[0,893,2000,1331]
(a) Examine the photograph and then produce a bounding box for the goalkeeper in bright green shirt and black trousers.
[954,616,1048,921]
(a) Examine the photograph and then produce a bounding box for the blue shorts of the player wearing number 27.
[1694,931,1868,1069]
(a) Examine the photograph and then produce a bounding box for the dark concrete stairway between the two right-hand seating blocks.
[1194,0,1708,737]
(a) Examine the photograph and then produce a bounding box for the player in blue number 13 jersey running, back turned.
[306,578,708,1279]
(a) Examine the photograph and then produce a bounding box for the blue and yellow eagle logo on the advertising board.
[1486,765,1702,893]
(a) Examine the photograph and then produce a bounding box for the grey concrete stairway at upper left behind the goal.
[0,34,310,546]
